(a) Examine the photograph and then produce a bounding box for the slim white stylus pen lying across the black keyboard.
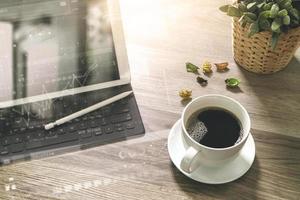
[45,91,132,130]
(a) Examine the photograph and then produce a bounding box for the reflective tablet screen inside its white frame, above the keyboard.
[0,0,120,102]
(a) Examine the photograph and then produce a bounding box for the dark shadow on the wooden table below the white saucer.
[170,158,260,199]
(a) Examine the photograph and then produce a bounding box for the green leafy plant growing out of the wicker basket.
[220,0,300,50]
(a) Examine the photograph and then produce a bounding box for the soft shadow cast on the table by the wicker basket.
[239,56,300,134]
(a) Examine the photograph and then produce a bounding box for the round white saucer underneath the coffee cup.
[168,120,255,184]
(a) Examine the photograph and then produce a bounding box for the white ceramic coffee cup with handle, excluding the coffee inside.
[180,94,251,173]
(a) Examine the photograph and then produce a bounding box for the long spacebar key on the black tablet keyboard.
[26,134,78,149]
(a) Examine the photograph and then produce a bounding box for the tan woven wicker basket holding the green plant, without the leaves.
[233,20,300,74]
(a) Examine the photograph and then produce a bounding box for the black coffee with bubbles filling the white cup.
[187,107,243,148]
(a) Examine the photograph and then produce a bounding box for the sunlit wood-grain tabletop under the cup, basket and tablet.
[0,0,300,200]
